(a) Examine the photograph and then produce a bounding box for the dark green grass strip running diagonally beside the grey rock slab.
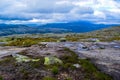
[61,48,112,80]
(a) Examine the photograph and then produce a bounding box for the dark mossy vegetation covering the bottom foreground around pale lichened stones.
[0,48,112,80]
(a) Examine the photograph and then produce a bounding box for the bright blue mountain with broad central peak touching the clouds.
[38,21,116,33]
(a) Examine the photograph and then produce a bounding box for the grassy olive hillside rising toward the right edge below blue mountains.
[66,26,120,41]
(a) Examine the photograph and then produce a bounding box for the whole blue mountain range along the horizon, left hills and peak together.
[0,21,118,36]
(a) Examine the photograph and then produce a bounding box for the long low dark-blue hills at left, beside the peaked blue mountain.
[0,24,69,36]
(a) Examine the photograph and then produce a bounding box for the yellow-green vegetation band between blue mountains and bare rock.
[0,27,120,47]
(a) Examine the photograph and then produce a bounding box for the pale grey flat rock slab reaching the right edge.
[41,42,120,80]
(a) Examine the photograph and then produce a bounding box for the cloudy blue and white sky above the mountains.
[0,0,120,24]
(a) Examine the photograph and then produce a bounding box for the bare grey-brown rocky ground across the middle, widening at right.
[0,42,120,80]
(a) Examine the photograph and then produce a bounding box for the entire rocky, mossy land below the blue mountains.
[0,27,120,80]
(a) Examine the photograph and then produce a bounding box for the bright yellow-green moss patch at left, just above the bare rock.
[6,37,57,47]
